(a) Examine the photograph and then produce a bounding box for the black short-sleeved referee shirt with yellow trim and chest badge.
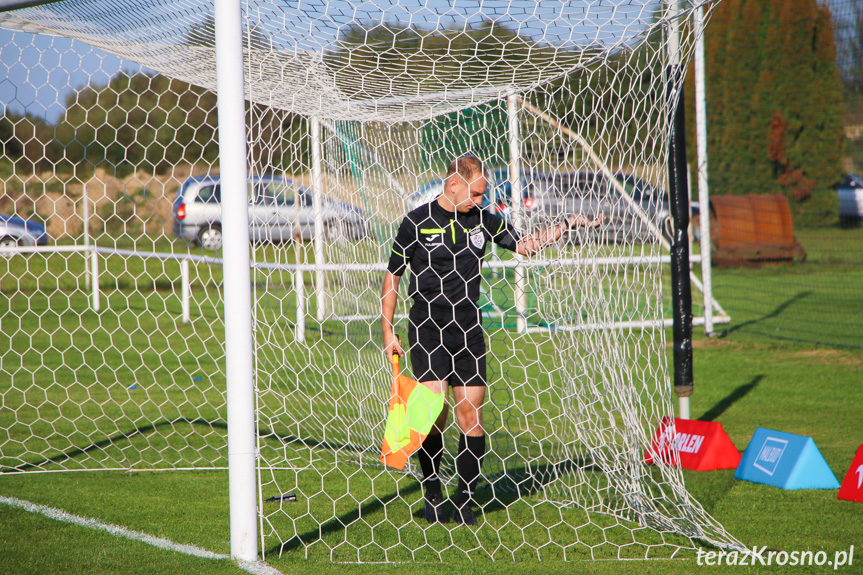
[387,200,520,308]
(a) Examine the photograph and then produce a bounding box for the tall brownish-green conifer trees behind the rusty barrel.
[688,0,844,224]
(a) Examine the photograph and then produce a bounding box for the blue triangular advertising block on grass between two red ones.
[734,427,839,489]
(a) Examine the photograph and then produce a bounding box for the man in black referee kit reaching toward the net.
[381,156,602,525]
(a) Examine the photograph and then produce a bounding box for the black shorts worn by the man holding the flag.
[408,305,486,386]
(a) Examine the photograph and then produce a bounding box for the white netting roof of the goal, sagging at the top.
[3,0,664,121]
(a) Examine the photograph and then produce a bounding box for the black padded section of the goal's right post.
[667,64,692,404]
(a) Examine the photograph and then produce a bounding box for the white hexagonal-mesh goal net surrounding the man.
[0,0,742,561]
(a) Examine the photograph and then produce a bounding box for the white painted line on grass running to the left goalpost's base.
[0,495,282,575]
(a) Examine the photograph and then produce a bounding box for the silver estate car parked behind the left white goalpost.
[173,176,368,250]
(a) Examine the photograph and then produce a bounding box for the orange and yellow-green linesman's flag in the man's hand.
[381,355,444,469]
